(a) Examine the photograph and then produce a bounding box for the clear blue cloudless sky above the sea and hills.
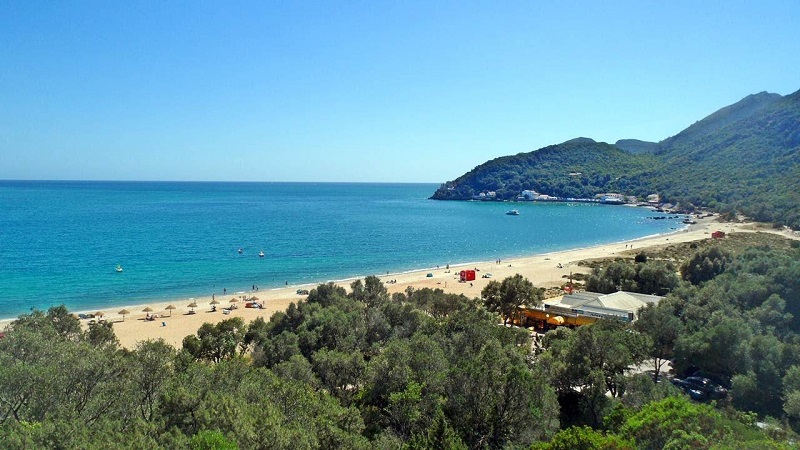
[0,0,800,182]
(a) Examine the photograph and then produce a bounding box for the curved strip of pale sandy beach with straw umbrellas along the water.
[0,217,796,348]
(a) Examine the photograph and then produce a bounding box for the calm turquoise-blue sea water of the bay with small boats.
[0,181,682,318]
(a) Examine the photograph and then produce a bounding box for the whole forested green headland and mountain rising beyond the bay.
[431,91,800,229]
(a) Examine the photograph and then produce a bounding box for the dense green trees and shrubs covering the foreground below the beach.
[0,237,800,449]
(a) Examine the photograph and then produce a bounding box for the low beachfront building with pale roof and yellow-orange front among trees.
[521,291,664,330]
